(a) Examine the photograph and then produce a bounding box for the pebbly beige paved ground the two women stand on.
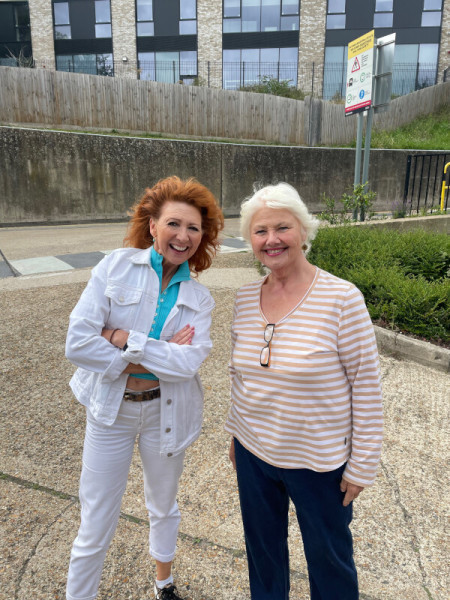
[0,222,450,600]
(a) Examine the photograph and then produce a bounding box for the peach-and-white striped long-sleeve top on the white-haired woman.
[225,269,383,486]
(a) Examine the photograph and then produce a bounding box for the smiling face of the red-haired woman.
[150,200,202,266]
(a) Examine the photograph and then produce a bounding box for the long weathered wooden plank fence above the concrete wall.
[0,67,450,145]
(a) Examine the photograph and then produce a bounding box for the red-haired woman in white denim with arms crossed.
[66,176,223,600]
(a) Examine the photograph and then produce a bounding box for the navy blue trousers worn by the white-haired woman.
[234,439,358,600]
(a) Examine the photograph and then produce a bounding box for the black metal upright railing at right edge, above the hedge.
[403,153,450,215]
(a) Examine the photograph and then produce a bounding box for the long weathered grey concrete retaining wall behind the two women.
[0,127,444,225]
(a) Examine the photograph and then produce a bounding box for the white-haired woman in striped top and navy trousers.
[226,183,382,600]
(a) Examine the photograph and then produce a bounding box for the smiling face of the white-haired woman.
[250,206,306,271]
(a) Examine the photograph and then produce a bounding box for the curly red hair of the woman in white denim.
[123,175,224,274]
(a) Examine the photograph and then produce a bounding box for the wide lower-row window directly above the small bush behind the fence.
[222,48,298,90]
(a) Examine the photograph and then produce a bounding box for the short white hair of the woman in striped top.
[241,183,319,253]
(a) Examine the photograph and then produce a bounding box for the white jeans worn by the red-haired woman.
[66,399,184,600]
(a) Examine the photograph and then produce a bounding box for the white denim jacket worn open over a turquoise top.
[66,248,214,456]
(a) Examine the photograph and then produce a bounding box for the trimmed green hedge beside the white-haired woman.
[308,226,450,343]
